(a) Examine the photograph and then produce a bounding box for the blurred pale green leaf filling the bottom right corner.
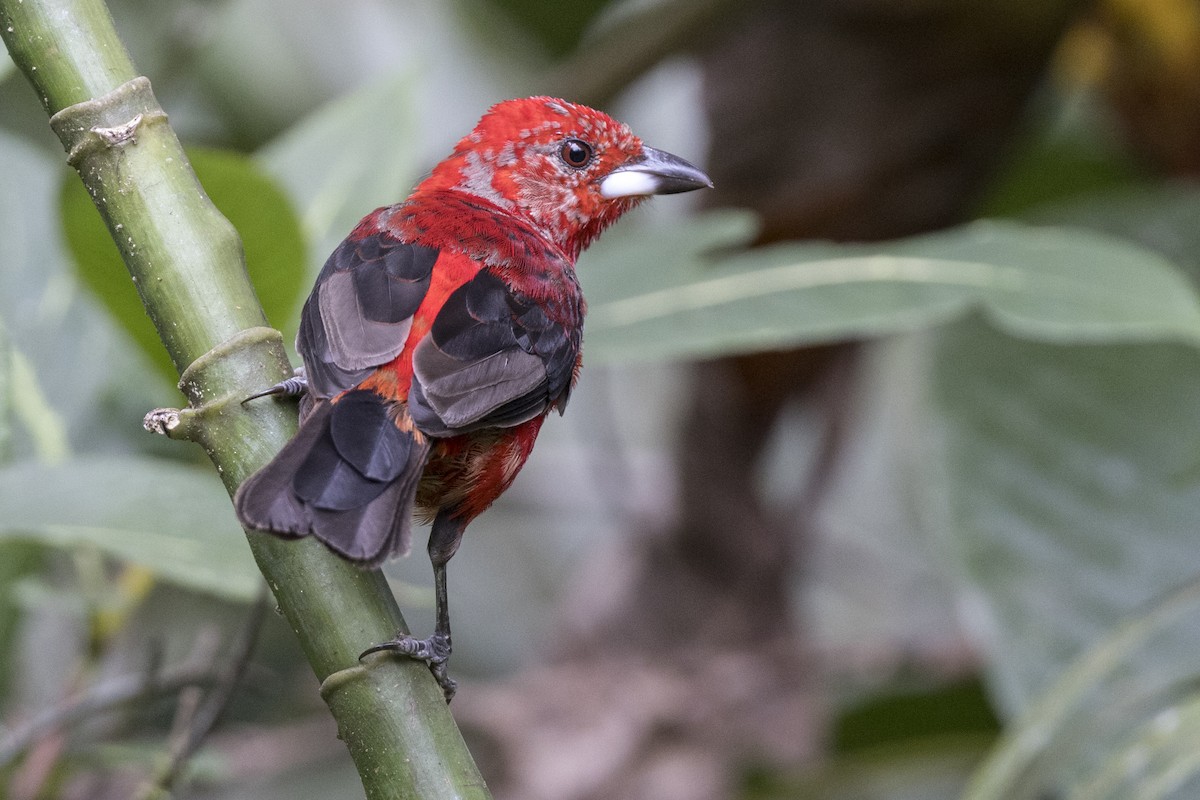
[962,583,1200,800]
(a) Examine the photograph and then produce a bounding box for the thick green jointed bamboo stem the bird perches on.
[0,0,490,800]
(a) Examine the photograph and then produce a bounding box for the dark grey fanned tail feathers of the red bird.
[234,391,428,566]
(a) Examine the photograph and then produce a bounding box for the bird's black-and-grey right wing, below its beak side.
[408,272,581,437]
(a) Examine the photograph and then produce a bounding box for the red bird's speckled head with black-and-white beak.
[418,97,713,257]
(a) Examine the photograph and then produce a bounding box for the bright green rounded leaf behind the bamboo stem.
[59,149,306,383]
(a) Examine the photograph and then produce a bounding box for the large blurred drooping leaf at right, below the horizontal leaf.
[926,321,1200,714]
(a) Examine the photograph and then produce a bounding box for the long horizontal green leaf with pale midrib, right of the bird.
[581,215,1200,361]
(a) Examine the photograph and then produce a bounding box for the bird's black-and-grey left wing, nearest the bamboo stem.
[296,231,438,397]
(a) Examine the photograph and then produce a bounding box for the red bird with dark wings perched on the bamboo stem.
[235,97,712,699]
